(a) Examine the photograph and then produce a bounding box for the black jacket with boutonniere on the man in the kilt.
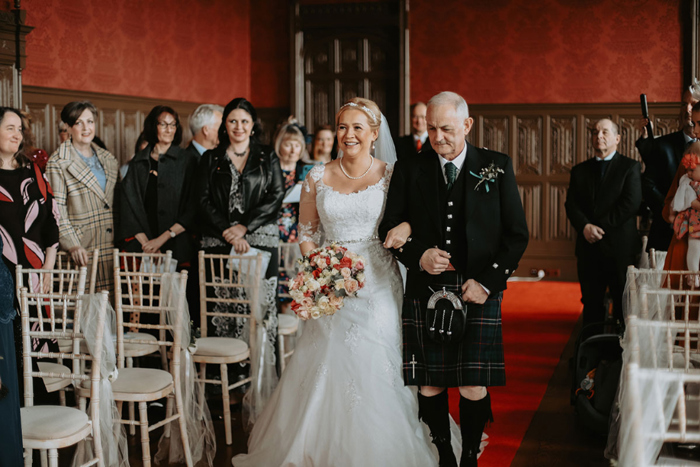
[379,143,529,297]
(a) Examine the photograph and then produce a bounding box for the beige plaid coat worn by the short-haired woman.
[46,140,119,291]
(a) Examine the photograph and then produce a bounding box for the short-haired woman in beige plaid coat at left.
[46,101,118,291]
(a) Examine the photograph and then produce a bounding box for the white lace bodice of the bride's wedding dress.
[300,164,394,244]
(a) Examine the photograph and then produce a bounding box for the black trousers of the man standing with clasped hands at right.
[577,253,632,326]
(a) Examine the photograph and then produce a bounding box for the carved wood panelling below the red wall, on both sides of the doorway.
[23,87,679,281]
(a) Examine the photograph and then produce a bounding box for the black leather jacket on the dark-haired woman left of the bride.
[196,141,284,240]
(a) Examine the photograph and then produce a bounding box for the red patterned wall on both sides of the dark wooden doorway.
[17,0,682,108]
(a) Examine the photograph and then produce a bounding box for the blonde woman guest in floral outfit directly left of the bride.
[275,119,310,302]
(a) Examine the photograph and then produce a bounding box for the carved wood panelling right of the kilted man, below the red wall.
[469,104,680,281]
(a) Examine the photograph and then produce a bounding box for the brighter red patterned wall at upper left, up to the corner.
[22,0,251,104]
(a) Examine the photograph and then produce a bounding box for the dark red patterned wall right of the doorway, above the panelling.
[410,0,682,104]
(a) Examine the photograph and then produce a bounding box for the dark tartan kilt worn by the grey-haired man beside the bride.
[402,273,506,388]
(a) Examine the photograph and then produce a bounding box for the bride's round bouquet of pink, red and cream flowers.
[289,243,365,320]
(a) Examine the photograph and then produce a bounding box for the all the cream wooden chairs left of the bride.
[17,250,298,466]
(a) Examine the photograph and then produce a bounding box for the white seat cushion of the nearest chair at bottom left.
[20,405,89,440]
